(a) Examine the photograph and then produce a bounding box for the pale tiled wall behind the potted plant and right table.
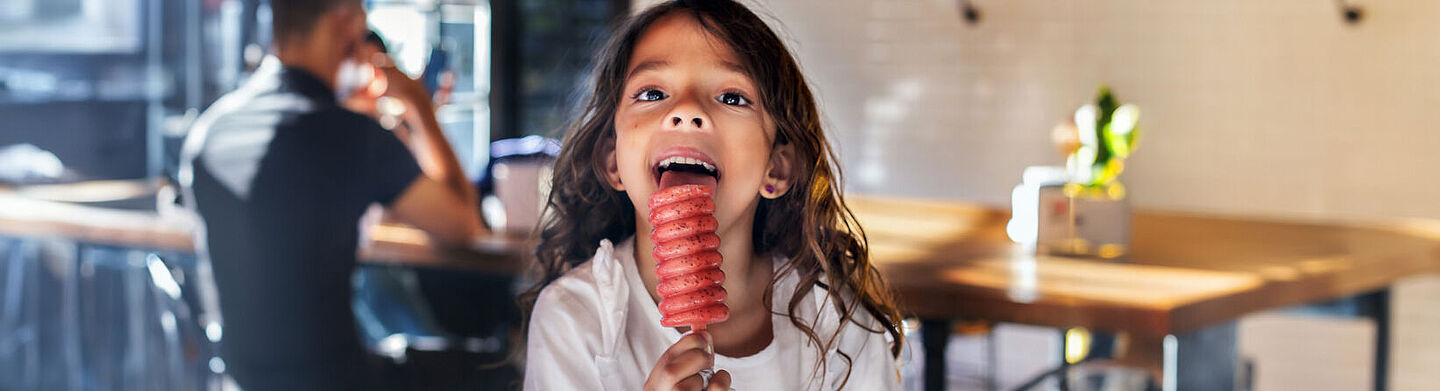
[636,0,1440,390]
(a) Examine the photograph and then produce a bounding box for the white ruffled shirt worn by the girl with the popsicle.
[524,237,900,391]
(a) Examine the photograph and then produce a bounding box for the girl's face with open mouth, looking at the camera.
[606,14,791,234]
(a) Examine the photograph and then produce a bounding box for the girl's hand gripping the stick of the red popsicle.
[645,331,730,391]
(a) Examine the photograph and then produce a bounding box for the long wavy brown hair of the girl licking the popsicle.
[520,0,903,381]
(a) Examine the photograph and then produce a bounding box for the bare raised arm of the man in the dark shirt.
[376,58,488,244]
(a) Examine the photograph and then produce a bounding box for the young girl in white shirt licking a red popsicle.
[524,0,901,390]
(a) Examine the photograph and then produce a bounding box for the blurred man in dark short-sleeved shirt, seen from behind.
[181,0,485,390]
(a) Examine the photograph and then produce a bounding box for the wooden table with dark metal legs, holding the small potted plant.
[851,197,1440,388]
